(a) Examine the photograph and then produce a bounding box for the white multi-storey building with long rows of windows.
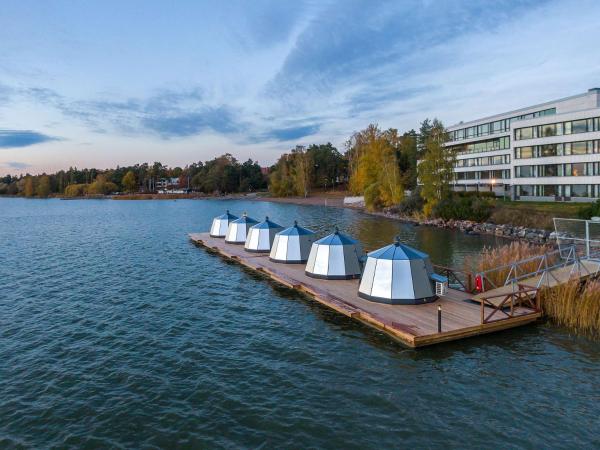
[446,88,600,201]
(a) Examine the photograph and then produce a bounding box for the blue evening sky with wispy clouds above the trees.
[0,0,600,175]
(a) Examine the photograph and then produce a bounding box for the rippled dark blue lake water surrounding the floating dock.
[0,199,600,449]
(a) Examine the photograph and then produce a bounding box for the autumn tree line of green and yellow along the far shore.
[0,119,462,216]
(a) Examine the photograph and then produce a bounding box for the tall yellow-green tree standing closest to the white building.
[418,121,455,216]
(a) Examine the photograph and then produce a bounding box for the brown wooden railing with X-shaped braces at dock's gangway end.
[481,284,541,325]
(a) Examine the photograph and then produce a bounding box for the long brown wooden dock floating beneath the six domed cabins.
[190,233,541,348]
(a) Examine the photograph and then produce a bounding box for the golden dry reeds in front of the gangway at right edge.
[538,280,600,336]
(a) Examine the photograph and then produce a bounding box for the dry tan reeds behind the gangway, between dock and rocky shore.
[465,241,550,289]
